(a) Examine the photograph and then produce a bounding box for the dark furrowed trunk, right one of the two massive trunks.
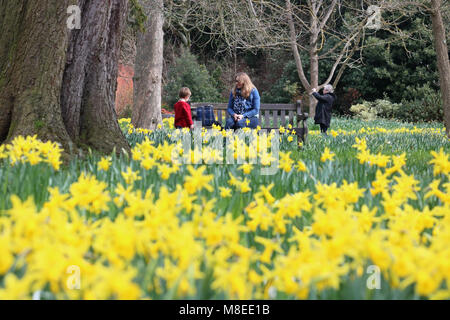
[61,0,129,153]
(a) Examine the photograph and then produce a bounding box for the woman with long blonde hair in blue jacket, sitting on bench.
[225,72,261,129]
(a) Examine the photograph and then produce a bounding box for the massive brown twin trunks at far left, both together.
[0,0,129,153]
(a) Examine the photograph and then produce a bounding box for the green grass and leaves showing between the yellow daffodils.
[0,118,450,299]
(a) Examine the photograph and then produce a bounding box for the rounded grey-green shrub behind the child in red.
[163,50,220,106]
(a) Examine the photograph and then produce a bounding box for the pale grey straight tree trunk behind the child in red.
[132,0,164,129]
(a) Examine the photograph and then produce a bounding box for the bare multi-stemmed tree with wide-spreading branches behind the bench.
[188,0,384,116]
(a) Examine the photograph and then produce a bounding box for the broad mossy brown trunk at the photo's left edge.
[0,0,71,150]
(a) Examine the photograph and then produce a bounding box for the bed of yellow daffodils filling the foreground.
[0,119,450,299]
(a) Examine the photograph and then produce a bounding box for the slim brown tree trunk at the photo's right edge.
[431,0,450,138]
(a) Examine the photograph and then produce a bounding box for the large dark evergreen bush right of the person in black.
[336,12,442,121]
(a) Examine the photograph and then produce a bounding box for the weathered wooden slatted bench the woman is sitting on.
[163,100,308,142]
